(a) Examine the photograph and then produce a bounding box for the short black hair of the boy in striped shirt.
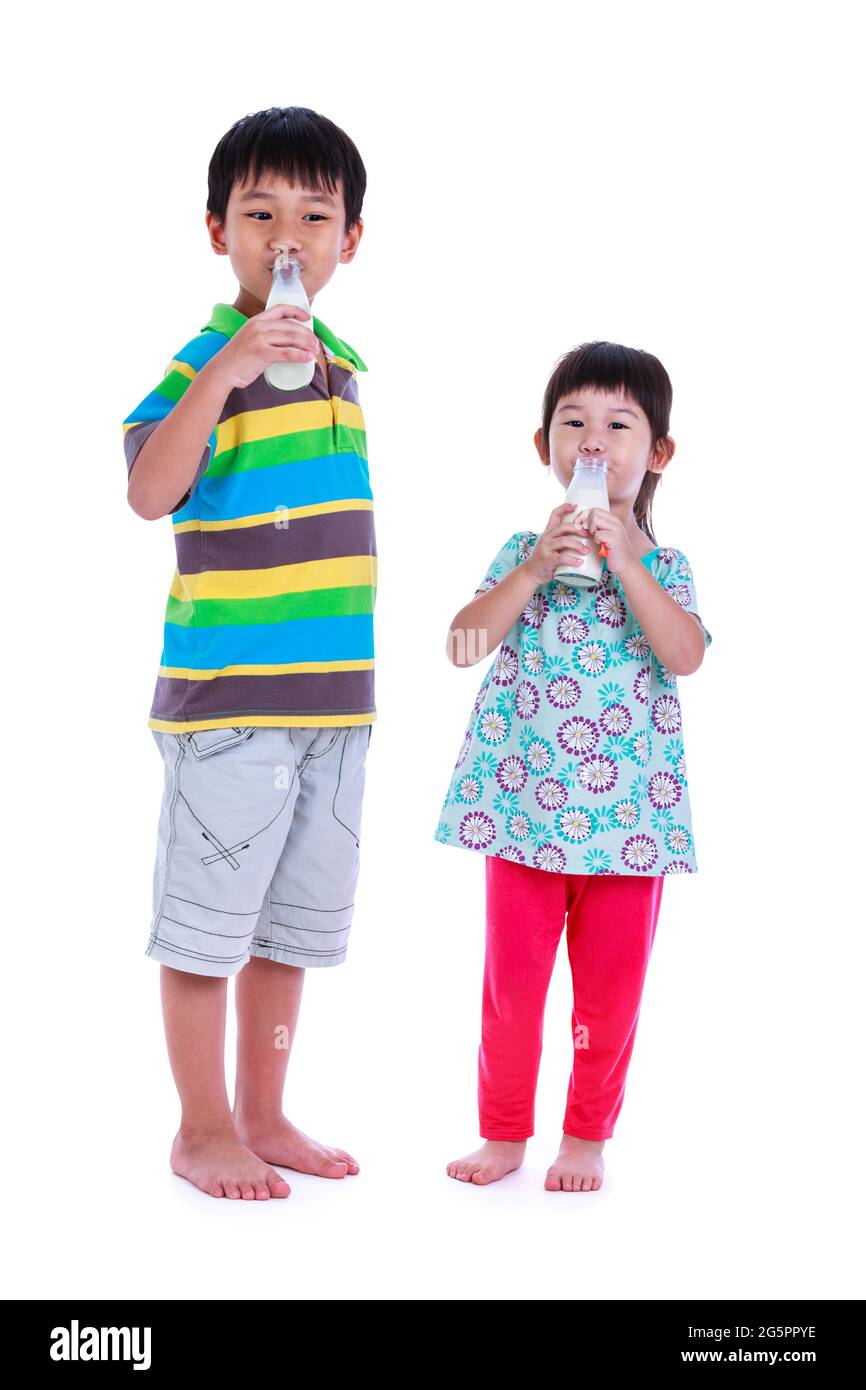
[207,106,367,231]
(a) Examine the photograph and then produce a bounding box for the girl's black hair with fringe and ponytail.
[542,342,673,545]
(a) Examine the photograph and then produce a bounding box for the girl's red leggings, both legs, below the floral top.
[478,855,662,1140]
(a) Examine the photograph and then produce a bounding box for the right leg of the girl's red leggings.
[563,874,663,1140]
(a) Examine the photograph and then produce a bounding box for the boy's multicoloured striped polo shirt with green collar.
[124,304,377,734]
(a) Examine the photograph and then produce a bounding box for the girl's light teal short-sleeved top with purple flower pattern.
[435,531,713,874]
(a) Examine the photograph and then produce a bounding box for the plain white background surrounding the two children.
[3,0,865,1300]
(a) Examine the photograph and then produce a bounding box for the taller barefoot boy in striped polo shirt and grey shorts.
[124,107,377,1200]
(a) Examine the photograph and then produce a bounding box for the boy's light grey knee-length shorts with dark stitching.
[145,724,373,976]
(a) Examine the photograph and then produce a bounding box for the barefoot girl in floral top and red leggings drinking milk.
[435,342,712,1193]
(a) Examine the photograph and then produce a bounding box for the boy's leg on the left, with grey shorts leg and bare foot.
[147,727,308,1198]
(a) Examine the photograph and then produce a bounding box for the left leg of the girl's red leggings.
[478,855,566,1140]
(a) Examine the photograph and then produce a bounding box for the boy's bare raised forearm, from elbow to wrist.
[126,353,232,521]
